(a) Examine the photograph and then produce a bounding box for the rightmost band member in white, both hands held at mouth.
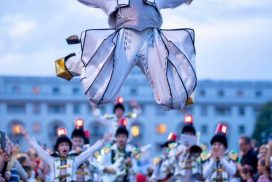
[202,123,237,182]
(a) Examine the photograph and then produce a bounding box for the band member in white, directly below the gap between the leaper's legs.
[99,126,137,182]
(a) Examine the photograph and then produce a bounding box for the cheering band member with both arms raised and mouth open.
[22,128,110,182]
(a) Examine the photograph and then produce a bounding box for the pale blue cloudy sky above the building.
[0,0,272,80]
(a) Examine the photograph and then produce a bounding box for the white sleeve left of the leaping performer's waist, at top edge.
[78,0,116,15]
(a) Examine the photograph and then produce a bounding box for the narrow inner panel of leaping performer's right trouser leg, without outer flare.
[138,28,172,108]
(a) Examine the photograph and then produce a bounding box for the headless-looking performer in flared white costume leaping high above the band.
[57,0,197,110]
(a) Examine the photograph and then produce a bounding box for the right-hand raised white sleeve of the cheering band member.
[75,139,104,169]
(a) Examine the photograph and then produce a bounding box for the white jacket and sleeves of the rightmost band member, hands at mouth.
[203,154,237,182]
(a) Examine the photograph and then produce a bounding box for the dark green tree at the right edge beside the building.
[253,102,272,144]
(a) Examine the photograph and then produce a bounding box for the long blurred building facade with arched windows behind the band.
[0,70,272,152]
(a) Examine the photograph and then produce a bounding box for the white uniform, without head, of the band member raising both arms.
[28,138,104,182]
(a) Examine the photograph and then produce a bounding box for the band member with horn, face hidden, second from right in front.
[169,115,202,182]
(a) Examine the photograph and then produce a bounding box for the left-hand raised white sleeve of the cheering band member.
[27,137,54,168]
